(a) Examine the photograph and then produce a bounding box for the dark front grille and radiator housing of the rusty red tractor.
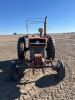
[29,38,46,60]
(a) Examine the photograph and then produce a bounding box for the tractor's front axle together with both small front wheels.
[10,60,65,81]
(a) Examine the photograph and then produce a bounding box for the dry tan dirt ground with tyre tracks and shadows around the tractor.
[0,34,75,100]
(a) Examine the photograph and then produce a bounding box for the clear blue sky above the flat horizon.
[0,0,75,34]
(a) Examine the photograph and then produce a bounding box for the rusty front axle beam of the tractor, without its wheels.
[16,60,58,75]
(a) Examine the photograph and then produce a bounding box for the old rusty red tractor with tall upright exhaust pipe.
[11,16,65,80]
